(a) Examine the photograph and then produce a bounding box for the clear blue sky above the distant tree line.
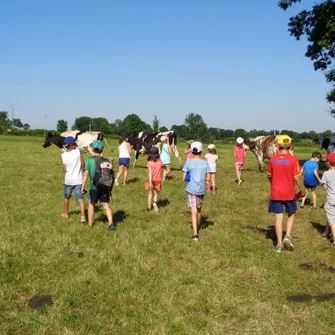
[0,0,335,132]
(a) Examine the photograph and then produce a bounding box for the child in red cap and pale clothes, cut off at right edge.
[321,152,335,247]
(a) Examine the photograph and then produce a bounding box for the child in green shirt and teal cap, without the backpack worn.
[81,140,116,230]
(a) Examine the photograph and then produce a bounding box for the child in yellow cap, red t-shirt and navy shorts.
[266,135,306,252]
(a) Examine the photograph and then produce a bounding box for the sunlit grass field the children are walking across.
[0,137,335,335]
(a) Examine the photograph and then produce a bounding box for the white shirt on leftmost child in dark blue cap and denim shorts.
[62,149,83,185]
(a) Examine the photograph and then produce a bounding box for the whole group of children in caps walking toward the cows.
[61,134,335,252]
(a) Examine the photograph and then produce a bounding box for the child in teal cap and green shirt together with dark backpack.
[81,140,116,230]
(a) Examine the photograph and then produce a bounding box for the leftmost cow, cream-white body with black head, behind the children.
[43,130,112,155]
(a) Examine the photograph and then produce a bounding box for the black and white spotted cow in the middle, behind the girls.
[129,130,182,167]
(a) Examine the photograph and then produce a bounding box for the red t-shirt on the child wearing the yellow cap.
[266,154,301,201]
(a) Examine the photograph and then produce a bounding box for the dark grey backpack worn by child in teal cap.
[93,156,115,194]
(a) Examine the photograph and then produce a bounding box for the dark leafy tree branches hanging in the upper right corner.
[278,0,335,117]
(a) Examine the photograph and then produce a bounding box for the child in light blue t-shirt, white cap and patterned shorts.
[183,142,210,241]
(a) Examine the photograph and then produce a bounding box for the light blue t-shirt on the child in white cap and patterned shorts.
[183,159,211,195]
